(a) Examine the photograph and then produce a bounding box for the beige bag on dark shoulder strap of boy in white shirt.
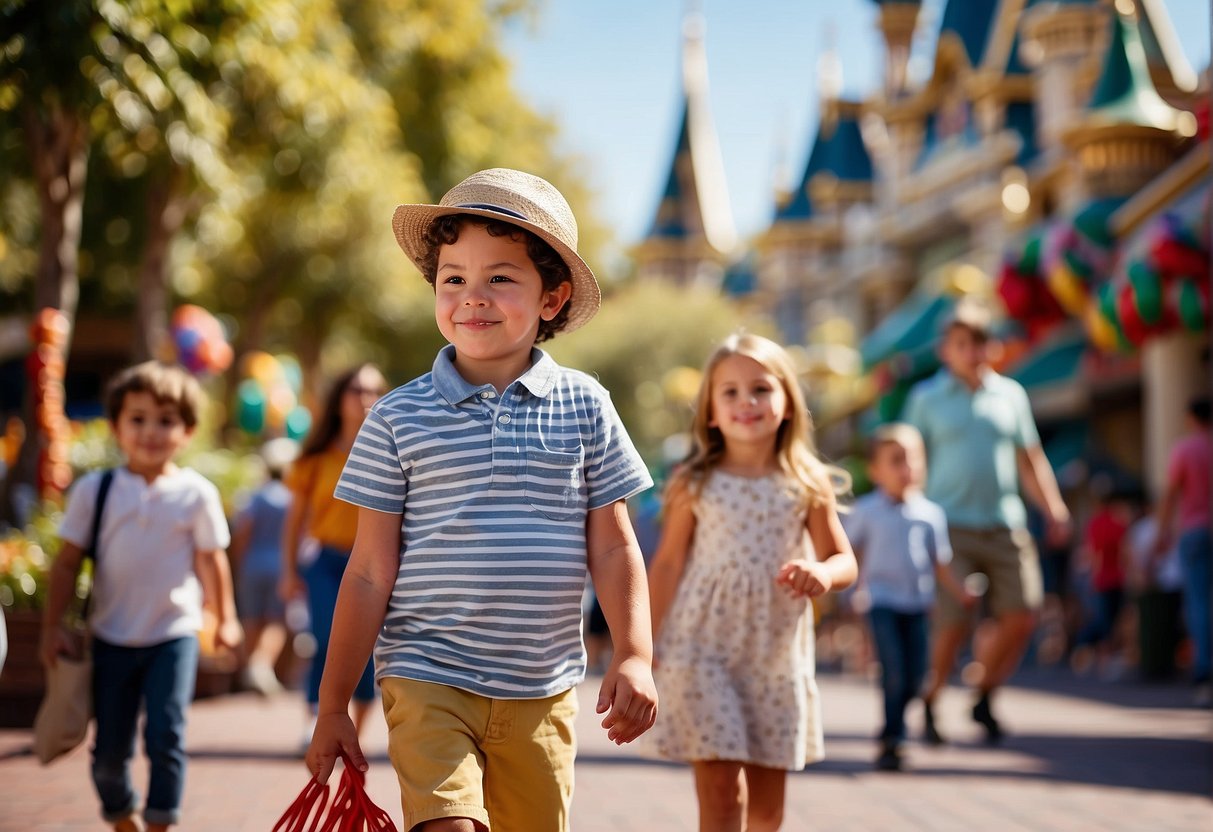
[34,471,114,765]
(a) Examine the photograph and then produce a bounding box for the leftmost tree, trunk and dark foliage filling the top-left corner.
[0,0,246,519]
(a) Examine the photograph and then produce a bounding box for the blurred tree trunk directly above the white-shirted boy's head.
[135,161,186,361]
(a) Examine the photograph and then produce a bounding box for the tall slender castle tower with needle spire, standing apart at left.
[633,13,738,293]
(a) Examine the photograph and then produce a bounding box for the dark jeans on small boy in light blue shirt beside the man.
[869,606,927,743]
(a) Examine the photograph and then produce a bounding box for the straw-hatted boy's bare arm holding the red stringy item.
[307,507,402,785]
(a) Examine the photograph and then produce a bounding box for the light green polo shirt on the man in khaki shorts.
[905,367,1041,529]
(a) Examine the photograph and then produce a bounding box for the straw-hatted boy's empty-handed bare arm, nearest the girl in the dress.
[586,500,657,745]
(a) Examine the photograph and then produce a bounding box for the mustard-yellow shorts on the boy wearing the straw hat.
[380,677,577,832]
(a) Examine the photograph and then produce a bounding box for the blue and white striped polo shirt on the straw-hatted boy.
[336,347,653,699]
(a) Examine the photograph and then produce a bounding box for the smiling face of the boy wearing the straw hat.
[434,223,573,391]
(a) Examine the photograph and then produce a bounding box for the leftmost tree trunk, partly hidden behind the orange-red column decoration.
[0,104,89,524]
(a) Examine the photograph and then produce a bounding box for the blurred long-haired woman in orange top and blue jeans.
[279,364,387,750]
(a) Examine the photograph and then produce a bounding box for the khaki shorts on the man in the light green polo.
[936,526,1044,625]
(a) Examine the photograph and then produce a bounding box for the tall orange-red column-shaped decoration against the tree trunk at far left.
[25,307,72,498]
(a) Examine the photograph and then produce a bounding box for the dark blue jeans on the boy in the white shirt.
[92,636,198,824]
